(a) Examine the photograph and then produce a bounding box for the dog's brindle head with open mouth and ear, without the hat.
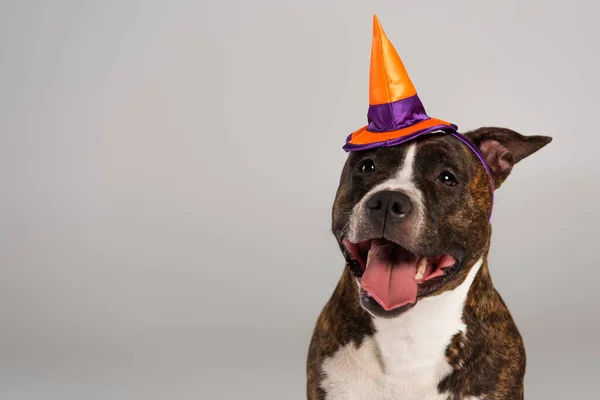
[333,128,551,318]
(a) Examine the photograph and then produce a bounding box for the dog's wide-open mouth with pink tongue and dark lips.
[342,238,459,312]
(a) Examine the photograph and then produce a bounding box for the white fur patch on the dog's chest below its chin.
[321,260,482,400]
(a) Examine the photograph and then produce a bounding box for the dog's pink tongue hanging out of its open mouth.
[361,241,417,311]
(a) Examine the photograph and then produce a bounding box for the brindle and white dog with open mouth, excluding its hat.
[307,127,552,400]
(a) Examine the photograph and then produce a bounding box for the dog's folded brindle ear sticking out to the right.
[465,127,552,189]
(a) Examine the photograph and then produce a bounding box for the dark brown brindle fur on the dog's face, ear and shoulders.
[307,128,551,400]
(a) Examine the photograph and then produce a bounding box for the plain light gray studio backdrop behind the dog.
[0,0,600,400]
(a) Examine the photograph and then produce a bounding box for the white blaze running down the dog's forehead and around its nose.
[348,143,425,243]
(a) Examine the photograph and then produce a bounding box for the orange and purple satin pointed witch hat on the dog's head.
[344,15,457,151]
